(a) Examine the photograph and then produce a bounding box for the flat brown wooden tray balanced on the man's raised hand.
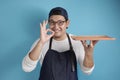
[71,35,115,40]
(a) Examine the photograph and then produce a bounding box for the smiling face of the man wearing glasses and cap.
[49,15,69,37]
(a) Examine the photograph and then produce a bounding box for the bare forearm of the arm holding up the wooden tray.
[83,53,94,68]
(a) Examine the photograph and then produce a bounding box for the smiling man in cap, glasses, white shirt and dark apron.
[22,7,97,80]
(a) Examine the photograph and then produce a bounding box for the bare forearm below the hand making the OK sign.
[29,40,44,61]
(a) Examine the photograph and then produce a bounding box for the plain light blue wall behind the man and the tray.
[0,0,120,80]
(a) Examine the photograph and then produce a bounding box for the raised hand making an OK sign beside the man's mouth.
[40,20,54,44]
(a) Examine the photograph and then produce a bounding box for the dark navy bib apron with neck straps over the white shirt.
[39,34,78,80]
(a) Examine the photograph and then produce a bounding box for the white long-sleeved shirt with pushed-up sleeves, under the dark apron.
[22,35,94,74]
